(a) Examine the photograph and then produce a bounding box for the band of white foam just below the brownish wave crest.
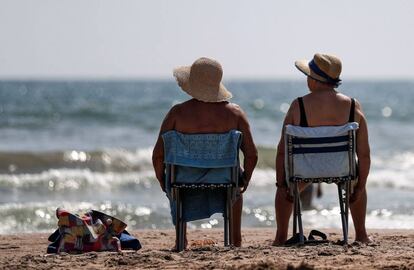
[0,166,414,197]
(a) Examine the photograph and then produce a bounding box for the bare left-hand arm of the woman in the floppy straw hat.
[152,107,176,191]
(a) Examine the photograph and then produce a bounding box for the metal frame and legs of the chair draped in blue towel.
[166,134,242,252]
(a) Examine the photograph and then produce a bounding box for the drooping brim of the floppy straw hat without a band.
[173,66,233,102]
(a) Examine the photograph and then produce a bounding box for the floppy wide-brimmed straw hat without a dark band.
[173,57,233,102]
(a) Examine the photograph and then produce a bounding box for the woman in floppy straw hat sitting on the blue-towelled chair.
[153,57,257,249]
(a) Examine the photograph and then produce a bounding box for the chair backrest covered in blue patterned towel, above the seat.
[162,130,242,183]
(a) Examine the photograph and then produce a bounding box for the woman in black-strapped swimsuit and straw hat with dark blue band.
[273,53,370,245]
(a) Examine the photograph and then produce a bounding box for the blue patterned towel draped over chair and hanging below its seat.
[162,130,241,224]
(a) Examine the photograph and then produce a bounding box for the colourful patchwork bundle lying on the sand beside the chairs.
[47,208,141,253]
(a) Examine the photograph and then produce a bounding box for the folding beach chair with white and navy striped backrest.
[285,122,358,245]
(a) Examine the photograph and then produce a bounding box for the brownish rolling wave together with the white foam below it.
[0,147,414,192]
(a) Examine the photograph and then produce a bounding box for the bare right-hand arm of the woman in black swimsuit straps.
[356,102,371,188]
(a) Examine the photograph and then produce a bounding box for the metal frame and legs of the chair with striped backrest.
[285,130,357,245]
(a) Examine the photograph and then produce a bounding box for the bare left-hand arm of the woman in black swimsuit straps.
[276,100,297,187]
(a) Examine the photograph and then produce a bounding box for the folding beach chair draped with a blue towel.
[162,130,242,251]
